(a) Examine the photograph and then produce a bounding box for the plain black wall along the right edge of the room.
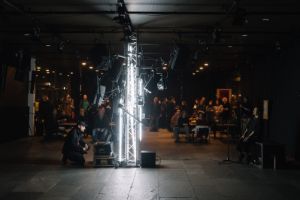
[270,41,300,158]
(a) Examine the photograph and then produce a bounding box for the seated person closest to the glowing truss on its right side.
[171,110,190,142]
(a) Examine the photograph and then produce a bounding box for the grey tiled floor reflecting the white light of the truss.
[0,130,300,200]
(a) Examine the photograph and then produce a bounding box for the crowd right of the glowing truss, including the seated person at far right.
[150,96,260,162]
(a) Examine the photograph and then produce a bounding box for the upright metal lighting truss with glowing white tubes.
[118,36,144,166]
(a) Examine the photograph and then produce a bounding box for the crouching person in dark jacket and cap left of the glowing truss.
[62,121,89,167]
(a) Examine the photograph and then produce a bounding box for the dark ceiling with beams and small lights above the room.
[0,0,300,71]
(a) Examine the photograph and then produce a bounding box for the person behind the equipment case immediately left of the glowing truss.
[92,105,109,143]
